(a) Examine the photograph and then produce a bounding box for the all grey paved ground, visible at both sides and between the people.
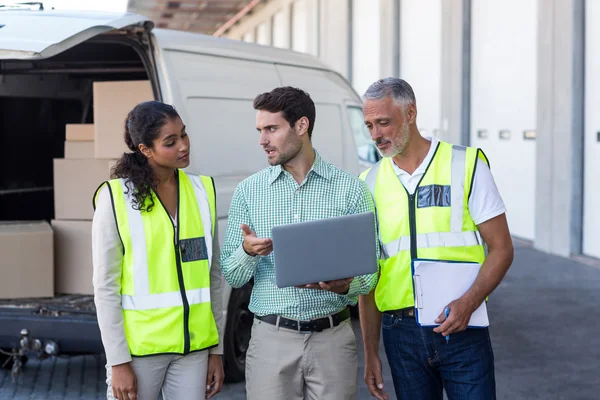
[0,241,600,400]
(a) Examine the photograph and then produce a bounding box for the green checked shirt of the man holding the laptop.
[221,151,379,320]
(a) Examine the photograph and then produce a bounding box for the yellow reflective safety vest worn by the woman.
[94,171,219,356]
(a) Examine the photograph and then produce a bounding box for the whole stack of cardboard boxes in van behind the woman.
[52,81,154,294]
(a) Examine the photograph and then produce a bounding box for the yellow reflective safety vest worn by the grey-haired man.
[360,142,488,312]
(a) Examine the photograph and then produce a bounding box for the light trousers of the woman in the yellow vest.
[106,350,208,400]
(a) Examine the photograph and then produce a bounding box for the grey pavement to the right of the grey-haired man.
[489,241,600,400]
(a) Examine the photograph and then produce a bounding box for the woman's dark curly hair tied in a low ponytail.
[111,101,179,212]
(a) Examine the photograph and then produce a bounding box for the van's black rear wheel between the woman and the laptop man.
[224,283,254,382]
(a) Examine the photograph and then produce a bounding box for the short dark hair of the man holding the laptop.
[253,86,316,138]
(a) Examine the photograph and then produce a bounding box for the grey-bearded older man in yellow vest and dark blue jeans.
[359,78,513,400]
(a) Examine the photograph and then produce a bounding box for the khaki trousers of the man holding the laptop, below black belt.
[246,319,358,400]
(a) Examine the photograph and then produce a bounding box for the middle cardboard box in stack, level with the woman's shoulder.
[54,158,116,220]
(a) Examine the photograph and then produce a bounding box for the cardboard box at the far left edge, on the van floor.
[0,221,54,299]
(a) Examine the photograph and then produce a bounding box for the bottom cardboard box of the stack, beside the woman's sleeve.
[52,220,94,294]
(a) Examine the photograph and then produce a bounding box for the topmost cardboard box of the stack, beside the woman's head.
[94,81,154,158]
